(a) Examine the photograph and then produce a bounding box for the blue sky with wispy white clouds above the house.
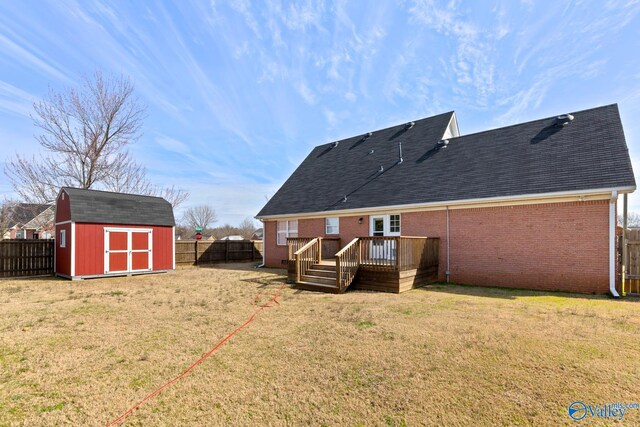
[0,0,640,224]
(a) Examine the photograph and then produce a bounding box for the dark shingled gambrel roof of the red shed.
[62,187,175,226]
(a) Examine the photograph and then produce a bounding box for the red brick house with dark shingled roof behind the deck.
[257,104,636,296]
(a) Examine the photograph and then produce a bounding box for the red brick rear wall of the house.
[265,200,609,293]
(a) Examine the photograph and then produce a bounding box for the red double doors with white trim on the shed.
[104,228,153,274]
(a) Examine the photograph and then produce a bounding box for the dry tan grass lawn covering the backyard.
[0,264,640,426]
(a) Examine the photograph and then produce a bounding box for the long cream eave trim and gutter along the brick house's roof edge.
[256,186,636,220]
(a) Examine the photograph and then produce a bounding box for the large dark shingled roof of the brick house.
[258,104,635,217]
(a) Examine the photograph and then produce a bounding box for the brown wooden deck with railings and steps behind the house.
[288,237,439,293]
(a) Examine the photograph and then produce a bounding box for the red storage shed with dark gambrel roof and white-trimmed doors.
[55,187,175,279]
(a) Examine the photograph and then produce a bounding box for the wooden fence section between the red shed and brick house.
[176,240,263,265]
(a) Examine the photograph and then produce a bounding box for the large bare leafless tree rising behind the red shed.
[5,71,188,207]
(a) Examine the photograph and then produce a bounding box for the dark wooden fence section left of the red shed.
[0,239,55,277]
